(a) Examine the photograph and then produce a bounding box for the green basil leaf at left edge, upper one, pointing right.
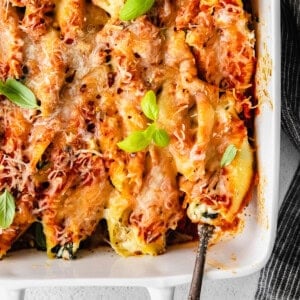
[0,78,39,109]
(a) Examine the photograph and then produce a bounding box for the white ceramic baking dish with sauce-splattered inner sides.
[0,0,280,300]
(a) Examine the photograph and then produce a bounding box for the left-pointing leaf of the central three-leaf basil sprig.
[117,129,151,153]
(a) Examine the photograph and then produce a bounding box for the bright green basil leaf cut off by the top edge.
[120,0,155,21]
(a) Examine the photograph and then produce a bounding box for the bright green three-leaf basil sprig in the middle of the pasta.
[117,91,170,153]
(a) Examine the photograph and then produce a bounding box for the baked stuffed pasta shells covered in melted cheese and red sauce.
[0,0,255,259]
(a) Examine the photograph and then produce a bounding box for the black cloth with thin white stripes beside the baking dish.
[255,0,300,300]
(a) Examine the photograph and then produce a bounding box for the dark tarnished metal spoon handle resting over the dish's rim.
[188,224,214,300]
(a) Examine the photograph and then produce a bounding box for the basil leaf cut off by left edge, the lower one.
[0,190,16,229]
